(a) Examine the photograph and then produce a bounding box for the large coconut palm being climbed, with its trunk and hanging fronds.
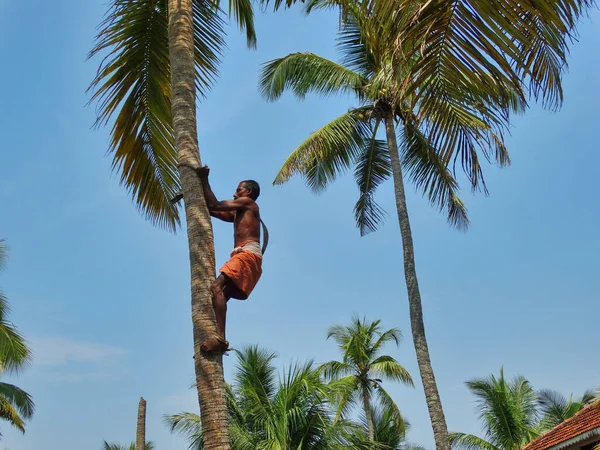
[90,0,256,450]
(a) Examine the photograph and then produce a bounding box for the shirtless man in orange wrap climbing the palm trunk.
[197,166,262,353]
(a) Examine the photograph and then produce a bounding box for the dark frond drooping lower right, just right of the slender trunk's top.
[400,118,469,230]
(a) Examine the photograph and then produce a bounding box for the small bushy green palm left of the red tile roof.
[450,369,540,450]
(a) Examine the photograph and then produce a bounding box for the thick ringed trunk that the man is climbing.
[168,0,229,450]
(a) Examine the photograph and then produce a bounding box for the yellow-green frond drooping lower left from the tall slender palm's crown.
[274,107,371,192]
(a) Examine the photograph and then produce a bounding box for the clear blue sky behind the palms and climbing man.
[0,0,600,450]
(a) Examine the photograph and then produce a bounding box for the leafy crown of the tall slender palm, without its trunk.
[260,6,472,235]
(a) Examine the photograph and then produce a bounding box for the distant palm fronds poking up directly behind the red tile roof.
[538,389,598,431]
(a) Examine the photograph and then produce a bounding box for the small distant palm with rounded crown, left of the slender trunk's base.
[320,316,414,442]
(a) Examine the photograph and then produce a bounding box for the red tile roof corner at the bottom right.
[523,402,600,450]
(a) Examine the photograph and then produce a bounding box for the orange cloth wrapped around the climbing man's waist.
[219,241,262,300]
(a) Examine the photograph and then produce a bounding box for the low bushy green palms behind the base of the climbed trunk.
[165,346,370,450]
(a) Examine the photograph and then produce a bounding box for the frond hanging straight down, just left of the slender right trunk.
[354,121,392,236]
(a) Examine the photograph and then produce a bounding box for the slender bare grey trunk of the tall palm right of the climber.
[385,112,450,450]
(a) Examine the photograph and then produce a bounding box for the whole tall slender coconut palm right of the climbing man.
[260,1,504,450]
